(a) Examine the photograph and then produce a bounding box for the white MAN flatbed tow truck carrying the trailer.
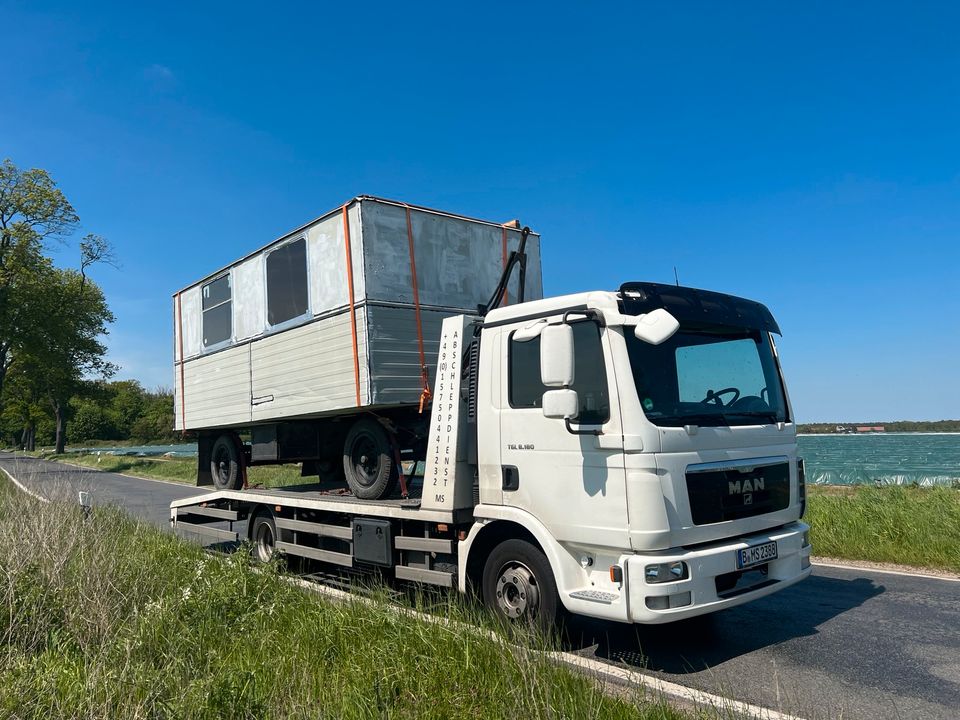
[170,200,811,624]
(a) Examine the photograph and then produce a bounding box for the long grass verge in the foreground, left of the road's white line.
[0,479,689,720]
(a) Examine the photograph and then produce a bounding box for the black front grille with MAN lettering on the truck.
[687,461,790,525]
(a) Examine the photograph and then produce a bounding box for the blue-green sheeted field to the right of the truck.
[798,433,960,485]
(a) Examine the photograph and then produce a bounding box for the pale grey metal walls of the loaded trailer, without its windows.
[174,197,543,430]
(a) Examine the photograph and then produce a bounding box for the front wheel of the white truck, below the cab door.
[482,538,562,629]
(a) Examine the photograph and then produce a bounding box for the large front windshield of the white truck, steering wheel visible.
[625,325,788,427]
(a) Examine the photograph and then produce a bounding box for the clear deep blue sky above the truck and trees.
[0,0,960,421]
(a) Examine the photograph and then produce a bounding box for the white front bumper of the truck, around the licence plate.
[620,521,810,624]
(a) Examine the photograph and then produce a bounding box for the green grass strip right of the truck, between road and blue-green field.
[804,486,960,573]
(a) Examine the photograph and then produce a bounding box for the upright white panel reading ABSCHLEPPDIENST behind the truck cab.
[420,315,472,510]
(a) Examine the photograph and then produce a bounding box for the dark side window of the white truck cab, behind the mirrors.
[508,321,610,425]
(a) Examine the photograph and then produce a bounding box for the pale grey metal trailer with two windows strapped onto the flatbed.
[173,196,543,497]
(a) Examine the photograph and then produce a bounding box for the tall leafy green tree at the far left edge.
[0,160,116,452]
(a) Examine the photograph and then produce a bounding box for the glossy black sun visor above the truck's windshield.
[620,282,782,335]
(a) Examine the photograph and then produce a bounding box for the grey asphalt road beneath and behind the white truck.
[0,453,960,720]
